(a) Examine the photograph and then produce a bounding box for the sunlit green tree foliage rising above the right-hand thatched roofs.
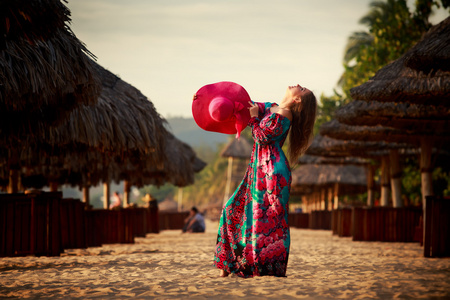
[339,0,437,99]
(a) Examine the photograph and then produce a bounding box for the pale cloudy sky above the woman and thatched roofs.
[67,0,450,118]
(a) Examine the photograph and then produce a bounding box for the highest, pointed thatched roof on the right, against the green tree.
[351,17,450,106]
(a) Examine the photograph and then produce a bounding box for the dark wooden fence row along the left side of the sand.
[0,192,159,257]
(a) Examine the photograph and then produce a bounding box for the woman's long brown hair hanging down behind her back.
[288,92,317,165]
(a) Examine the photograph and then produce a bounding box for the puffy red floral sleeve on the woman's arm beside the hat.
[249,113,283,145]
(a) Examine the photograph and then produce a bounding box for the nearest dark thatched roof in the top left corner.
[0,0,100,129]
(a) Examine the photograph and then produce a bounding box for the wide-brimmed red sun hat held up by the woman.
[192,81,251,138]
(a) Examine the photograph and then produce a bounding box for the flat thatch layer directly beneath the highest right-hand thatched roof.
[335,100,450,134]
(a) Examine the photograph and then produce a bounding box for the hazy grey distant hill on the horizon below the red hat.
[166,117,229,150]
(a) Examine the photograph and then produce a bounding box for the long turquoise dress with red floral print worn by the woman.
[214,103,291,277]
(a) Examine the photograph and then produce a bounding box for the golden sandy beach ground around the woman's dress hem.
[0,218,450,299]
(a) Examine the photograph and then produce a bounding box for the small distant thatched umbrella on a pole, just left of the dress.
[220,137,253,203]
